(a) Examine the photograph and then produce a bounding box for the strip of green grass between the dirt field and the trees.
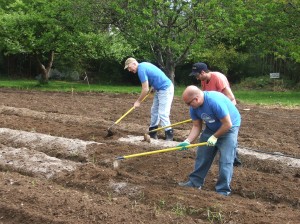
[0,80,300,107]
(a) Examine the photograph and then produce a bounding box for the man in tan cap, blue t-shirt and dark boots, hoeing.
[124,58,174,141]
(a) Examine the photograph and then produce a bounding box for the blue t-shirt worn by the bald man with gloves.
[190,91,241,131]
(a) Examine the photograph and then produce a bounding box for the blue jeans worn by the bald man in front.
[189,127,239,195]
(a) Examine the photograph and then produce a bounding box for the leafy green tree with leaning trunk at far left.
[0,0,132,83]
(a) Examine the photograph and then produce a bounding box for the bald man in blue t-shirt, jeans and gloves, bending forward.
[178,86,241,196]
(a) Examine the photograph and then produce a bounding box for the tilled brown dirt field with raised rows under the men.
[0,89,300,224]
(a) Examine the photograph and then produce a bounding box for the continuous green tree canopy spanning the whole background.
[0,0,300,84]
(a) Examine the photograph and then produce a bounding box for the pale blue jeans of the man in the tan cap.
[150,84,174,131]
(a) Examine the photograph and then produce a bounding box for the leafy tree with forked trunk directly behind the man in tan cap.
[110,0,251,81]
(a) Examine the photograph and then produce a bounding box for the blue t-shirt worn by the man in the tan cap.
[137,62,172,90]
